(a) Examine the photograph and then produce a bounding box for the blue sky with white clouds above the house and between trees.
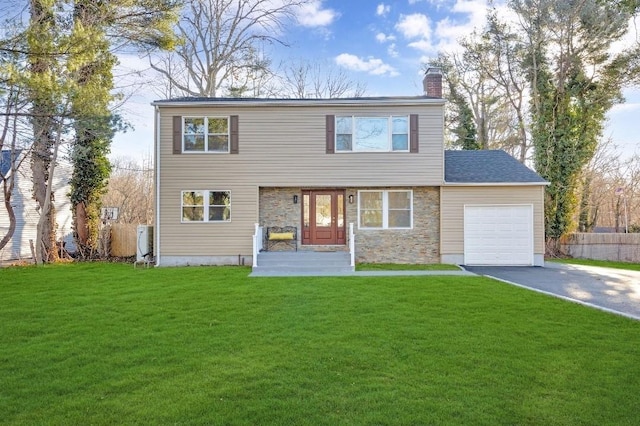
[111,0,640,158]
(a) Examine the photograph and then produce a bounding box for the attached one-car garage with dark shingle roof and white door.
[440,150,548,266]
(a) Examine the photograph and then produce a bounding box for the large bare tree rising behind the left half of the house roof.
[149,0,307,97]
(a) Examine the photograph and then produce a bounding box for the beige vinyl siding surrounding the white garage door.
[440,185,545,255]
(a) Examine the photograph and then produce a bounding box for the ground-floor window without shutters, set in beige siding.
[182,191,231,222]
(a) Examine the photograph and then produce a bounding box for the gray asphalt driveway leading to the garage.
[465,262,640,320]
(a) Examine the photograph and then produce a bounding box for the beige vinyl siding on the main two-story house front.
[158,103,444,256]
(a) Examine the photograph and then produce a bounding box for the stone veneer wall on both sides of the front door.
[259,187,440,263]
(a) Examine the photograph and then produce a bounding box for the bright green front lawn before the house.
[0,264,640,425]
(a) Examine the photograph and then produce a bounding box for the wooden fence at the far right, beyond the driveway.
[560,233,640,263]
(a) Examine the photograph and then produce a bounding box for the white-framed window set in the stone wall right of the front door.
[358,190,413,229]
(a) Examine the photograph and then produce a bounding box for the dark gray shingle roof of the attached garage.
[444,150,547,185]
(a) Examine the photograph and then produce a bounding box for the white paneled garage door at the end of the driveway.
[464,205,533,265]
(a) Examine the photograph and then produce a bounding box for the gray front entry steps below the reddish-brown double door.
[250,251,355,277]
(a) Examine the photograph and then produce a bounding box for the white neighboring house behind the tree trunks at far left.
[0,150,73,261]
